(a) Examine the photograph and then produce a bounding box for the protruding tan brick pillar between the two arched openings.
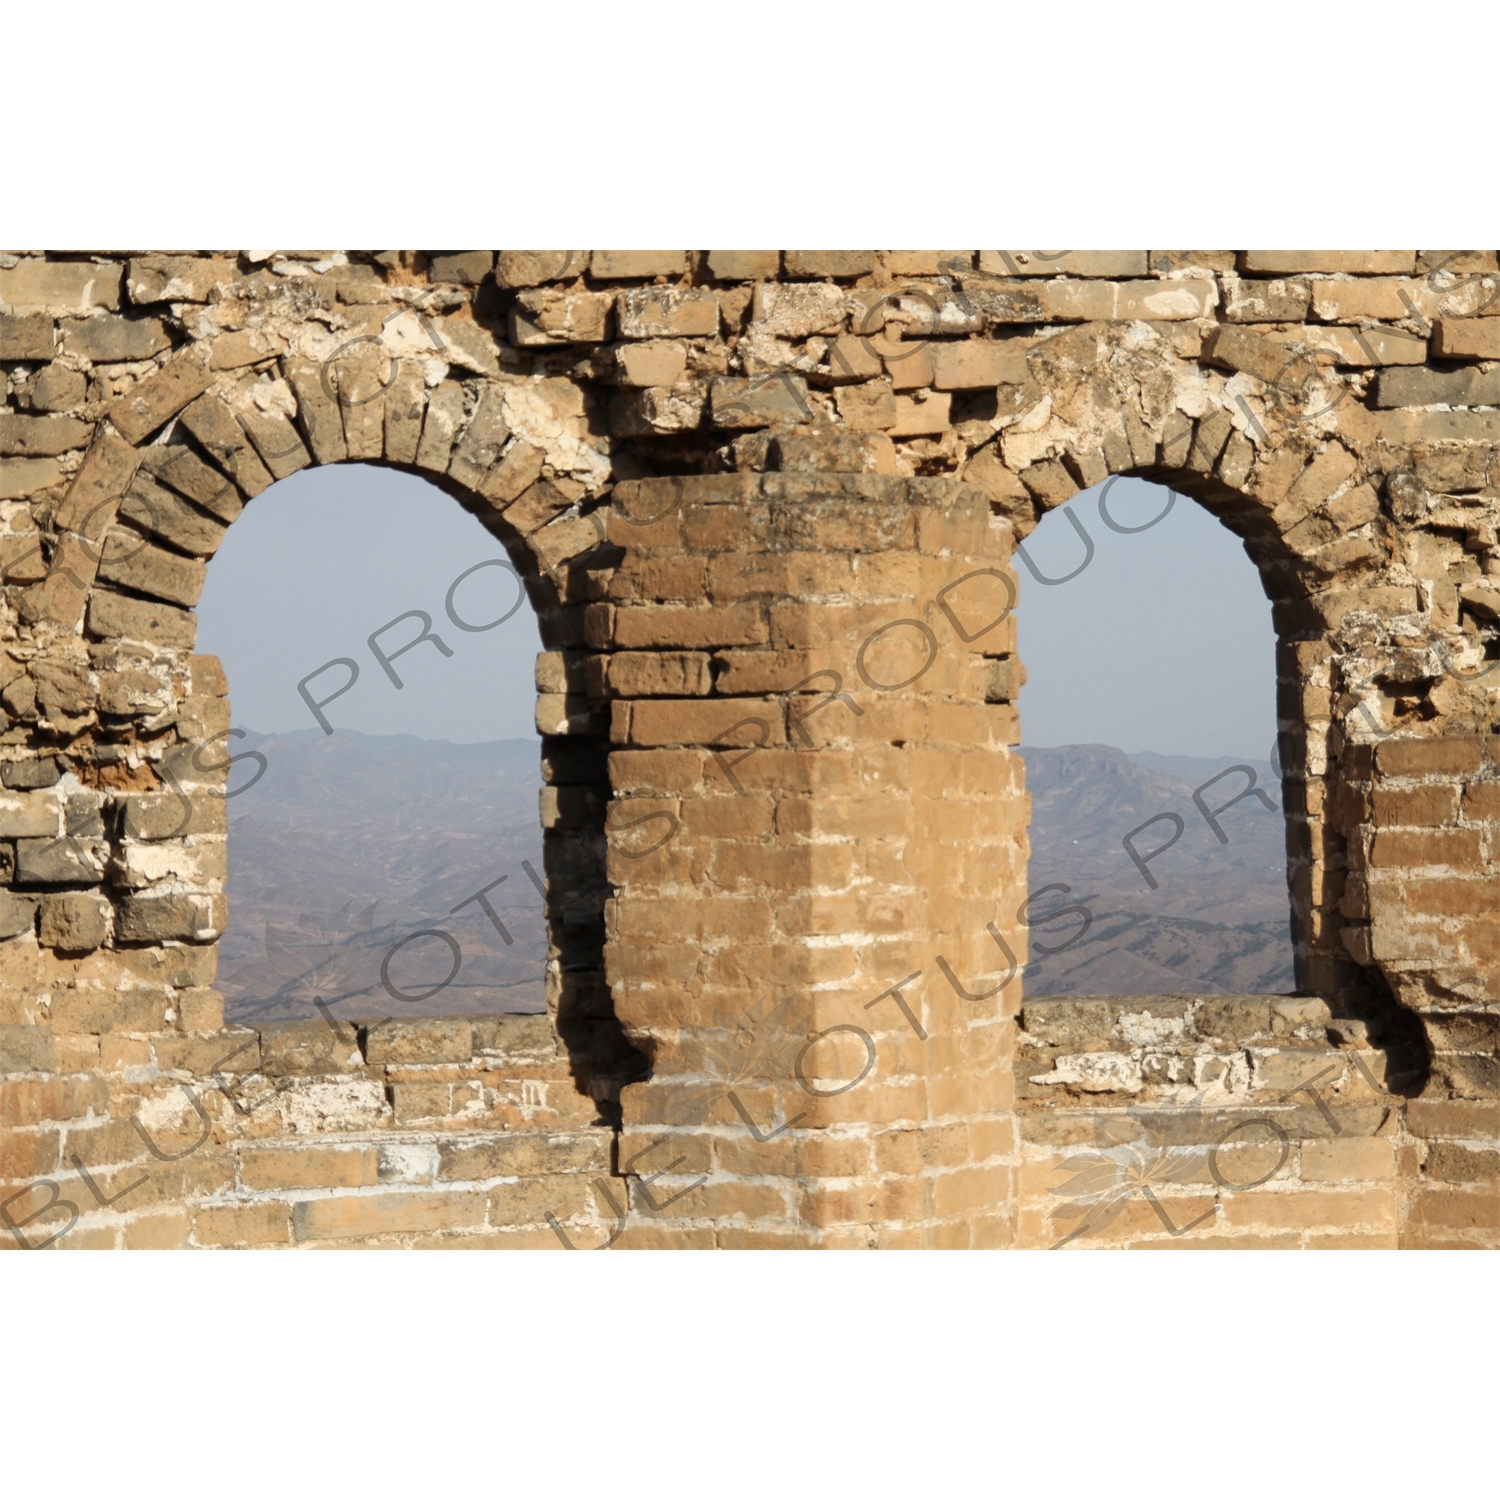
[587,474,1028,1247]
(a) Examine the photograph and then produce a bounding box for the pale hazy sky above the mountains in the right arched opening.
[1016,479,1277,761]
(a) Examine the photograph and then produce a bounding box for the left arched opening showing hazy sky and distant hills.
[200,465,548,1023]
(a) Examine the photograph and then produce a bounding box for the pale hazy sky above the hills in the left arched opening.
[198,464,542,743]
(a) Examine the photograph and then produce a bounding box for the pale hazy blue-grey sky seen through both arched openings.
[198,465,1275,761]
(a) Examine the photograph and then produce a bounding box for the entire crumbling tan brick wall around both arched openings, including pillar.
[0,251,1500,1248]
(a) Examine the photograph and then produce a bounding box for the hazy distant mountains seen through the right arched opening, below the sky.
[1022,746,1293,995]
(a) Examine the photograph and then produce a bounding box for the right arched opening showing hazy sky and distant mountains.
[1017,479,1295,996]
